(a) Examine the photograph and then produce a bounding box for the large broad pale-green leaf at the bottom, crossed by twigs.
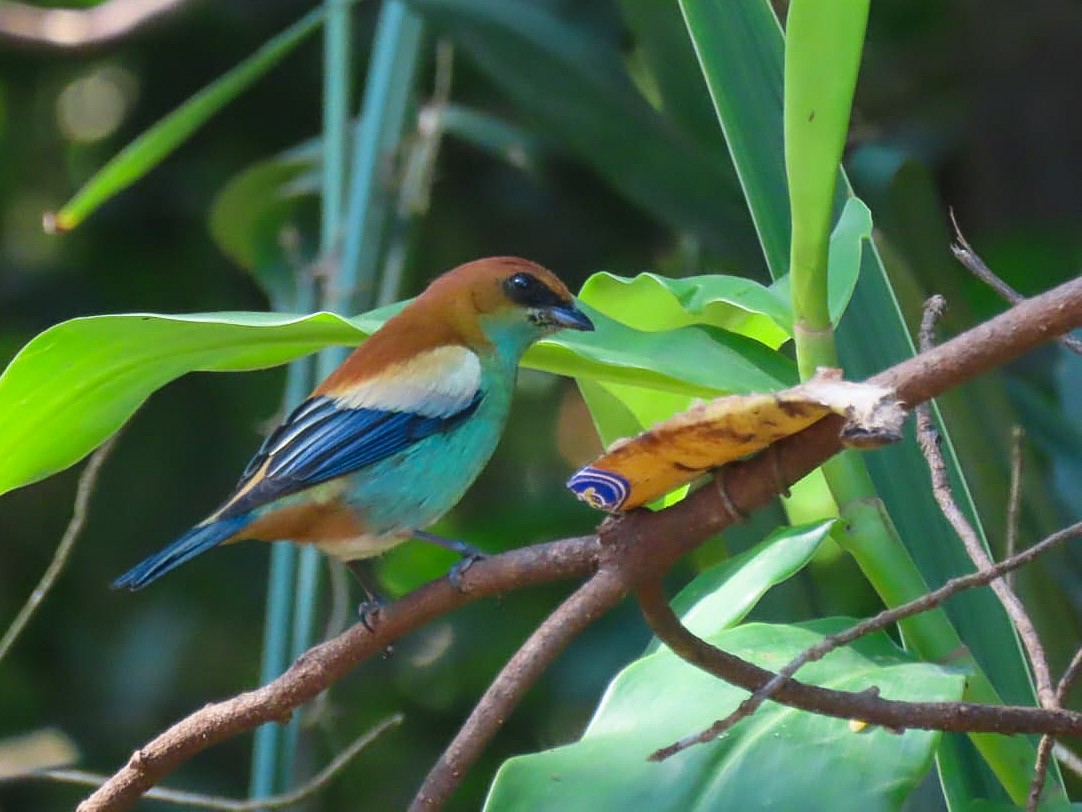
[485,618,964,812]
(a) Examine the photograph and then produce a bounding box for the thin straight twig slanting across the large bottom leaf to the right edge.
[640,522,1082,758]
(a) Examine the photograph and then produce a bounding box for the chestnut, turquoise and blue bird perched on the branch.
[113,257,594,602]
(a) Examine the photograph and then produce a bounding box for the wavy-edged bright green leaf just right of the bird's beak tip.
[579,273,792,349]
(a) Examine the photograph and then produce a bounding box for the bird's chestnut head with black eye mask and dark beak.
[422,257,594,354]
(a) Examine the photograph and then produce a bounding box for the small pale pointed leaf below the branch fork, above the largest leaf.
[646,520,835,654]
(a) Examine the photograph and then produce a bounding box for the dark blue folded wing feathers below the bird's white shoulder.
[216,391,481,519]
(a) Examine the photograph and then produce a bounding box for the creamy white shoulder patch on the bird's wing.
[335,346,480,417]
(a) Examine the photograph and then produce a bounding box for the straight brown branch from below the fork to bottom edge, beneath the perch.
[410,569,626,812]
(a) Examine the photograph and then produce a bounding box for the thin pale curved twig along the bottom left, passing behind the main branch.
[32,713,405,812]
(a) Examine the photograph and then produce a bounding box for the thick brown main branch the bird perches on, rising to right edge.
[81,280,1082,812]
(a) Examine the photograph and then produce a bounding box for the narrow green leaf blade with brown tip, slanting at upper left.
[50,8,324,232]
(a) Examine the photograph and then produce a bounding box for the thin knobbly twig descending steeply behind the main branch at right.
[915,296,1056,708]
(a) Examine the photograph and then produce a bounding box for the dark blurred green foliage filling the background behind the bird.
[0,0,1082,812]
